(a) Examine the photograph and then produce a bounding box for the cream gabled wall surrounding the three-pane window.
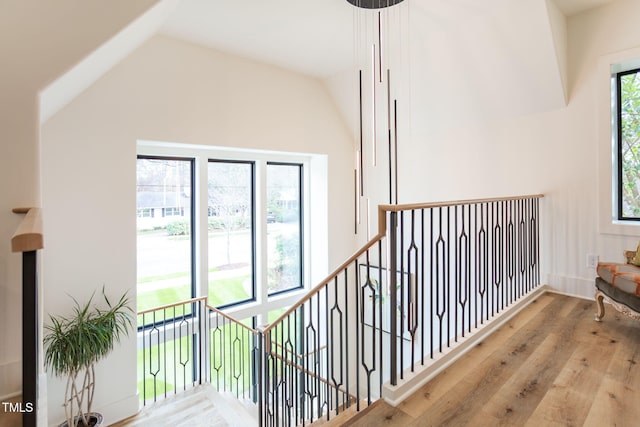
[42,36,354,422]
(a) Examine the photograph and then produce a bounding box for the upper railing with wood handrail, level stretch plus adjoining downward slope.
[259,195,542,426]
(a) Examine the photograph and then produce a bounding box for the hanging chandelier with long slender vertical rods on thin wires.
[347,0,409,235]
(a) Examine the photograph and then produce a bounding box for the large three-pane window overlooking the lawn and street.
[137,149,309,320]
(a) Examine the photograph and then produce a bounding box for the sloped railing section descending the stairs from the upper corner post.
[259,231,388,426]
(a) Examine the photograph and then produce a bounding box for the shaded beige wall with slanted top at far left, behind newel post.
[0,0,155,412]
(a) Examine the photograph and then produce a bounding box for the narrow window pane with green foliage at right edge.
[619,70,640,218]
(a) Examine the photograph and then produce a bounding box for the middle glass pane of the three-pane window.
[208,161,254,307]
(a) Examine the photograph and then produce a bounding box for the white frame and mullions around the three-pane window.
[137,140,328,325]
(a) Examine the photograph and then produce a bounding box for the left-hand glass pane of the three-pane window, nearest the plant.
[136,158,193,311]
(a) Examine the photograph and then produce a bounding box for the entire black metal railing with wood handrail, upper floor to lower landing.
[139,195,542,426]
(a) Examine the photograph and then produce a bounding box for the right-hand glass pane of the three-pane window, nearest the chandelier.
[267,163,303,294]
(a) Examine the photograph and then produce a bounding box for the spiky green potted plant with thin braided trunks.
[44,288,133,427]
